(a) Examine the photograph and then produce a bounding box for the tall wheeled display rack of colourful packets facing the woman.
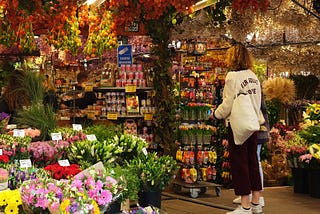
[173,47,221,198]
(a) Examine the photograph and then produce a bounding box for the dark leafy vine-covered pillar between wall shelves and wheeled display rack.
[146,12,177,155]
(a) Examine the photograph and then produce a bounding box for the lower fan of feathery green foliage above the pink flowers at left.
[14,103,58,140]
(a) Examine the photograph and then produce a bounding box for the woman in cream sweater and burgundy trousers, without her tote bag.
[213,43,263,214]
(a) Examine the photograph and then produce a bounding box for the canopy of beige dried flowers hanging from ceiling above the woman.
[172,0,320,76]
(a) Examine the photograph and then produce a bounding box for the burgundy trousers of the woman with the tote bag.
[228,126,262,195]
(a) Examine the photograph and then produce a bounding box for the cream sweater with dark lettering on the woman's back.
[214,70,261,122]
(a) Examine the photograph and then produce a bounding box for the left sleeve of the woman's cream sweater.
[214,72,236,119]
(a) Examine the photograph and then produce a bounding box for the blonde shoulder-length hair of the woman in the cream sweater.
[226,43,253,71]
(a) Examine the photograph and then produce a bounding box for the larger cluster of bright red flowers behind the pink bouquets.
[44,163,81,180]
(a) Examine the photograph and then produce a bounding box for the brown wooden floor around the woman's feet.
[161,185,320,214]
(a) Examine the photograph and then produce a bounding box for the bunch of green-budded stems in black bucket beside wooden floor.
[129,152,178,208]
